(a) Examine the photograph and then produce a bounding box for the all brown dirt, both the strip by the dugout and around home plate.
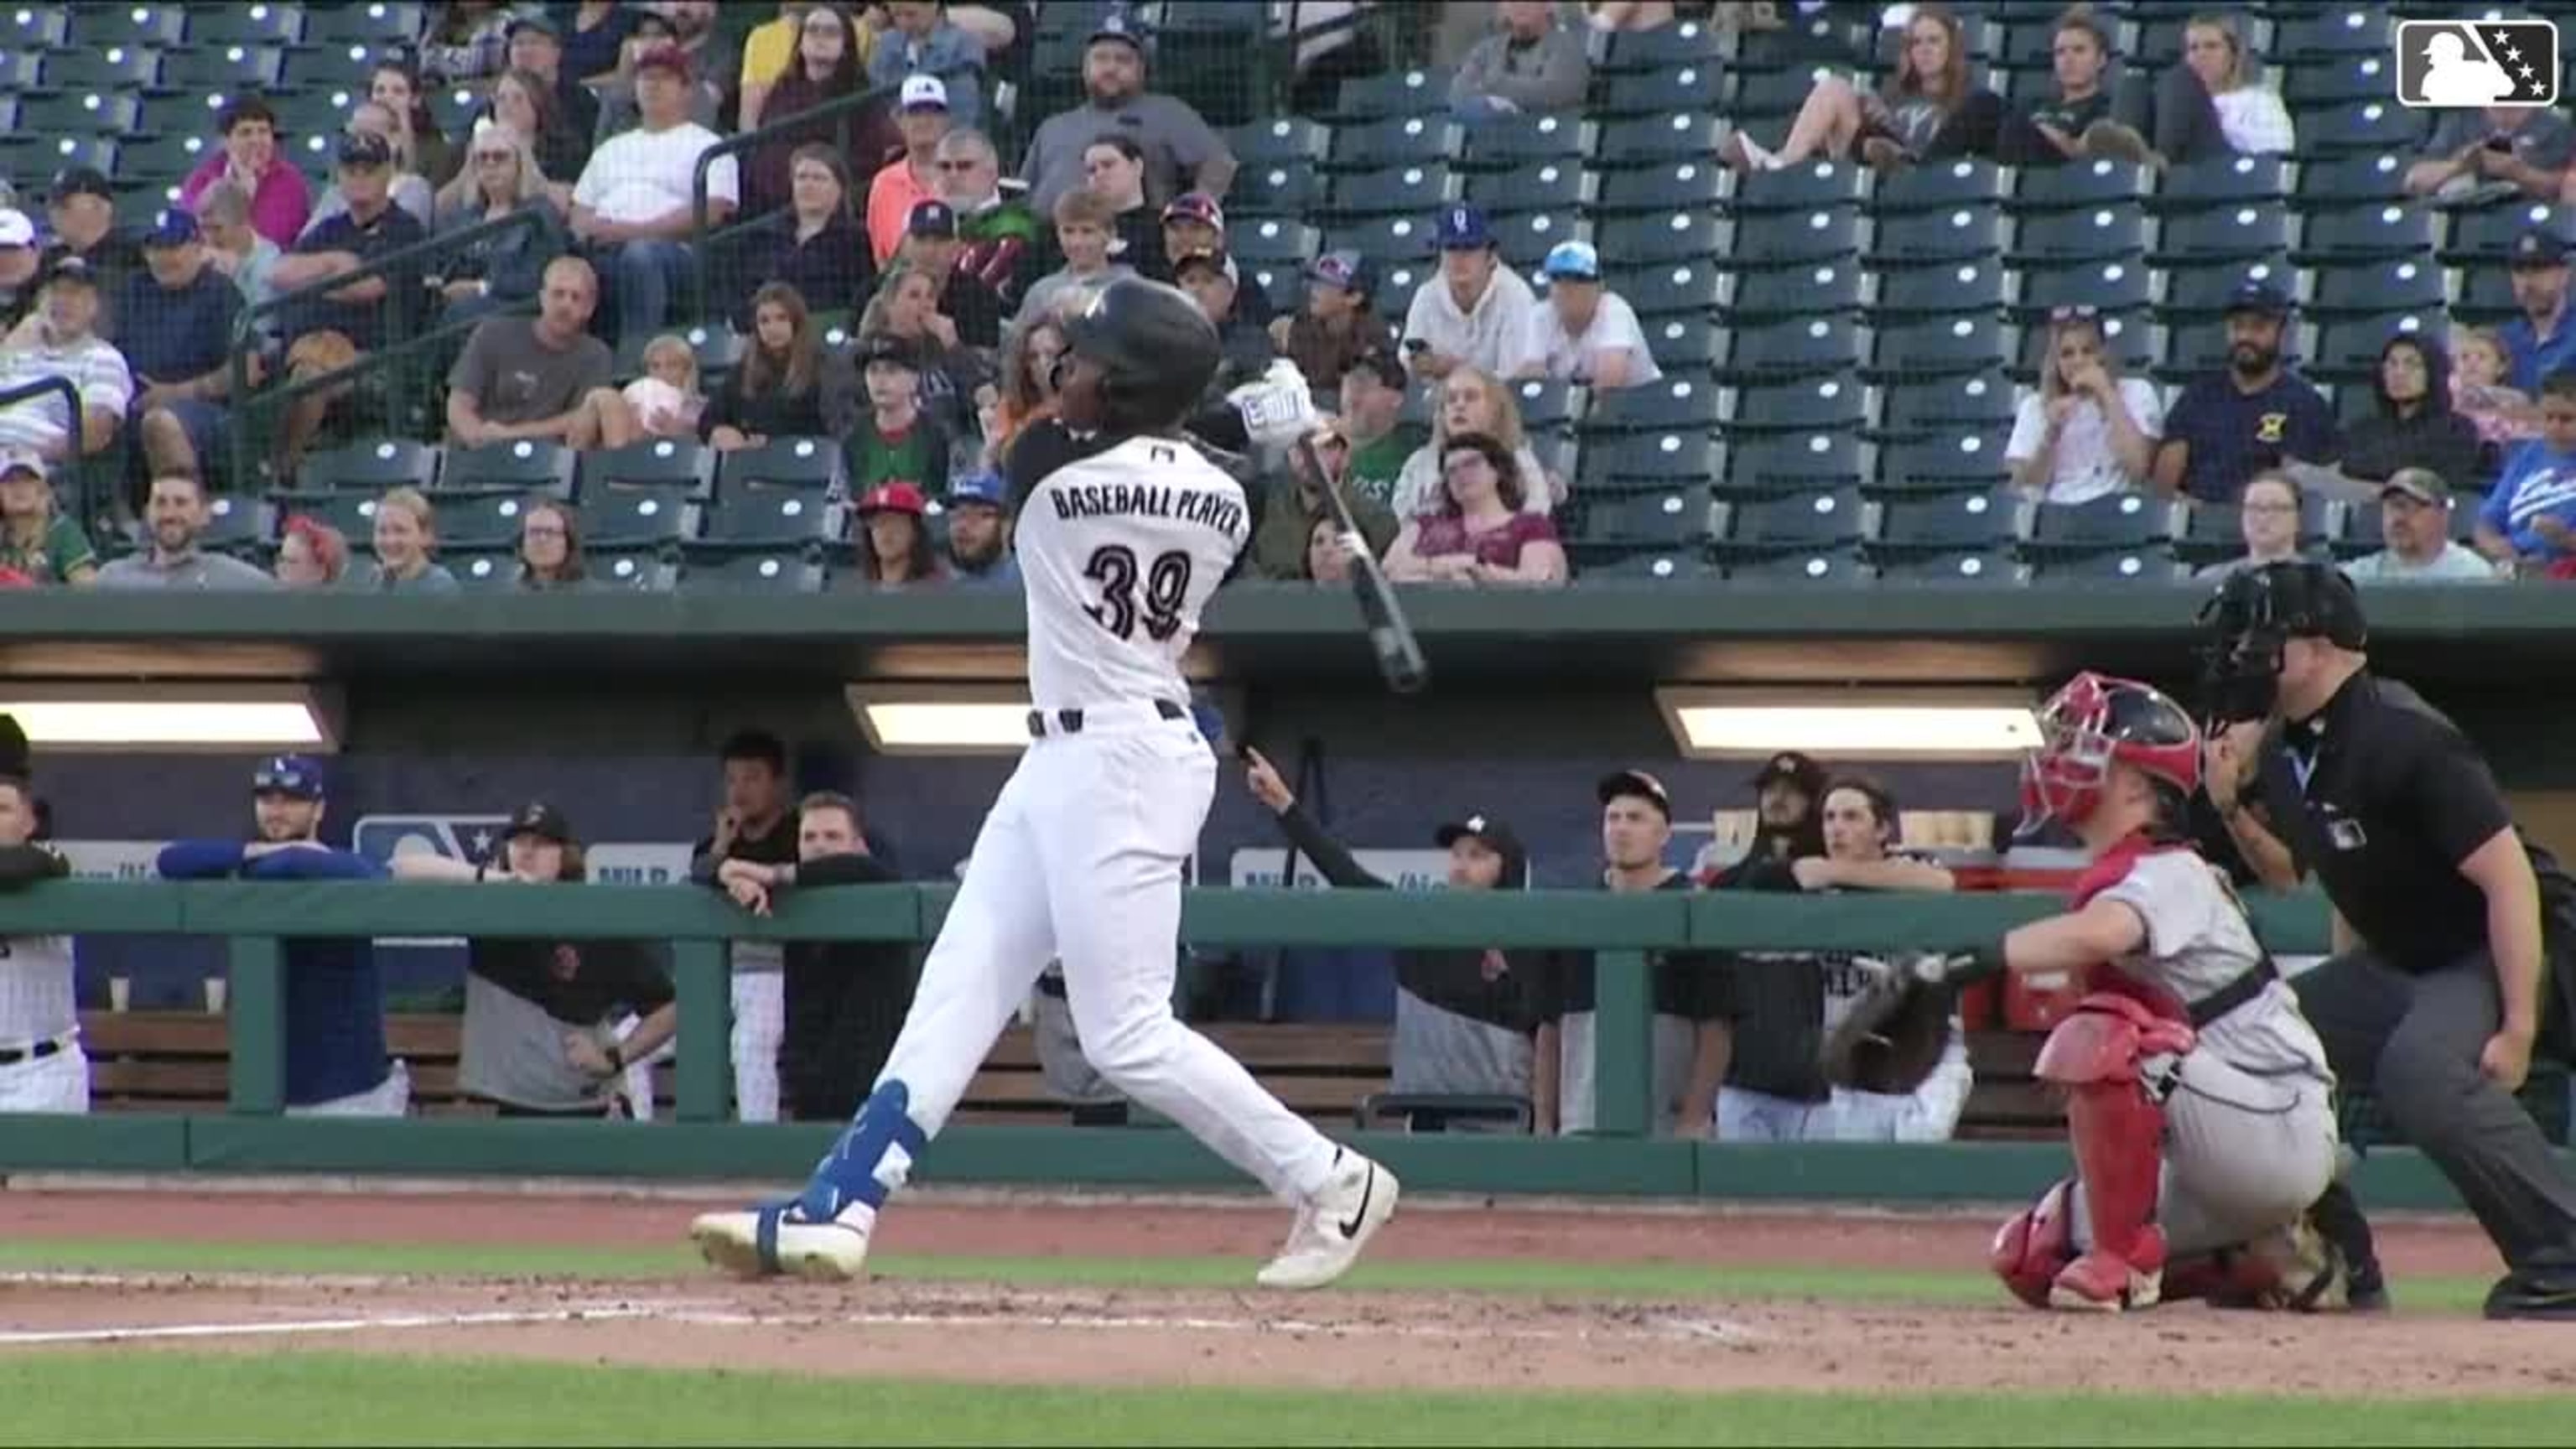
[0,1192,2545,1394]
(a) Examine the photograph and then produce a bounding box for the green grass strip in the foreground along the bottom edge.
[15,1353,2576,1446]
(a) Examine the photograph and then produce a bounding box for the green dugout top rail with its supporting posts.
[0,882,2326,1137]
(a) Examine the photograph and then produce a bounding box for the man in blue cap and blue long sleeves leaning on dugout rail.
[159,756,413,1116]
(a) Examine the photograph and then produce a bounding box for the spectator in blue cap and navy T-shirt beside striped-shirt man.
[108,206,242,477]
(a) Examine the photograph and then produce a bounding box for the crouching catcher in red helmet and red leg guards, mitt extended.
[1826,673,2341,1312]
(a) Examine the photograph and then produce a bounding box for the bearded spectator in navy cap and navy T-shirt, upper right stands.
[2156,278,2345,503]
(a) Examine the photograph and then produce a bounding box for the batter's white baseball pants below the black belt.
[879,704,1334,1202]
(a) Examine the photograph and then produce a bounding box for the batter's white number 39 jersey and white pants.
[879,425,1334,1202]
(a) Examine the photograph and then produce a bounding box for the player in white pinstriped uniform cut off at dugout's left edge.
[0,773,91,1111]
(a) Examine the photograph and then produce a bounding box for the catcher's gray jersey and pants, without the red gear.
[2074,851,2336,1255]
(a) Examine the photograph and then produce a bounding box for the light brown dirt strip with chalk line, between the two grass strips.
[0,1276,2576,1398]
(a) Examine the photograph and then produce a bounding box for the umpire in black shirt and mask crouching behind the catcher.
[2203,562,2576,1320]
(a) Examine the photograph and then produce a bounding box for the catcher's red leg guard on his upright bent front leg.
[2035,993,2192,1271]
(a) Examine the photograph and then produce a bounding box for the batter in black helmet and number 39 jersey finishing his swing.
[690,278,1396,1289]
